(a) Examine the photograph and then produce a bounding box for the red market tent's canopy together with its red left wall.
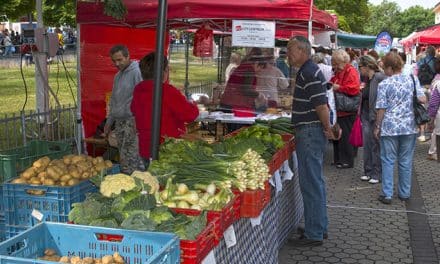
[77,0,336,148]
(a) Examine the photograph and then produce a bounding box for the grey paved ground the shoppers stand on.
[279,139,440,264]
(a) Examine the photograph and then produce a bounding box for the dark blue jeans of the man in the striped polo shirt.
[295,124,328,240]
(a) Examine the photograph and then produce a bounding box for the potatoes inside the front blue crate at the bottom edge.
[38,248,125,264]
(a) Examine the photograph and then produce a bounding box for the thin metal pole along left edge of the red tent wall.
[76,24,83,154]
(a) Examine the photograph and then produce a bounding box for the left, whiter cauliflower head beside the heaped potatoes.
[99,173,136,197]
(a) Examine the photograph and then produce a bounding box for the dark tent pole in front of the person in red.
[151,0,167,160]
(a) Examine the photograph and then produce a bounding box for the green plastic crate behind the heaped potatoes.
[0,140,72,182]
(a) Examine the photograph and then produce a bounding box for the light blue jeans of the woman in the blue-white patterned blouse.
[380,134,417,198]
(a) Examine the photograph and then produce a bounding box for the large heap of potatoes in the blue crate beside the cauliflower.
[12,154,113,186]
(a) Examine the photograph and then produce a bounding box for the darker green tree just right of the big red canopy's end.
[314,0,370,34]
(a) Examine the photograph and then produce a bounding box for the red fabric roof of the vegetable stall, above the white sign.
[77,0,337,31]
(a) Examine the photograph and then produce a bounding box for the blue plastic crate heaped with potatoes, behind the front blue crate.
[3,180,97,233]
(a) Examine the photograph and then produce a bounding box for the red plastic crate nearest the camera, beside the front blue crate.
[180,218,220,264]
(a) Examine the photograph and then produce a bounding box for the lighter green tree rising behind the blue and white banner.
[364,0,400,37]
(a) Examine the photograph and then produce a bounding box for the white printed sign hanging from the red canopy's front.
[232,20,275,48]
